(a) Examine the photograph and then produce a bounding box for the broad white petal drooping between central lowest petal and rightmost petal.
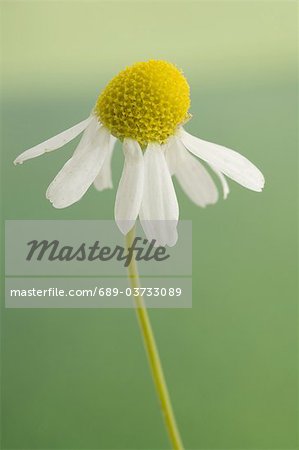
[171,138,218,207]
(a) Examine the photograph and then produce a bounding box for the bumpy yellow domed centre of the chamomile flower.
[95,60,190,145]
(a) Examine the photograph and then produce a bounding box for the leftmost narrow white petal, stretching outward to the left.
[14,115,93,164]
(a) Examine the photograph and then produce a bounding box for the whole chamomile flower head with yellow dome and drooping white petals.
[14,60,264,245]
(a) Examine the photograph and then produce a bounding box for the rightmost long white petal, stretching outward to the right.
[181,129,265,192]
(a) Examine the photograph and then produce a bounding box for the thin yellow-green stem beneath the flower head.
[126,227,183,450]
